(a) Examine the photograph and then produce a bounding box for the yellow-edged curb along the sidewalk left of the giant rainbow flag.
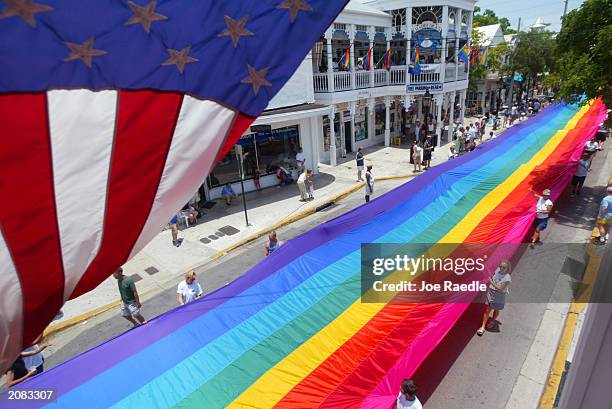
[43,174,417,337]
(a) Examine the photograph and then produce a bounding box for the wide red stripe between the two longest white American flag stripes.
[71,91,183,298]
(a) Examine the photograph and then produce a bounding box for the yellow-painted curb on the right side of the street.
[538,243,601,409]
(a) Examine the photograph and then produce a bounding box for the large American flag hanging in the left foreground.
[0,0,347,370]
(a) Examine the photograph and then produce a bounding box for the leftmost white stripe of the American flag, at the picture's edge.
[0,228,23,368]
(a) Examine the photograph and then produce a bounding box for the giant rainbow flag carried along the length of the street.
[10,100,606,409]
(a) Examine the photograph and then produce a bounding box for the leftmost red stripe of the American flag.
[0,93,64,346]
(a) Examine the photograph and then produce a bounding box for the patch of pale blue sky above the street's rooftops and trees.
[476,0,583,31]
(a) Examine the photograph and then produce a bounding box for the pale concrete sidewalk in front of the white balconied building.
[45,119,503,334]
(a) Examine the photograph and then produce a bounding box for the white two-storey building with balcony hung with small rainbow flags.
[205,0,475,199]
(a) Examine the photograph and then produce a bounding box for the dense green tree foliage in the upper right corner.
[551,0,612,107]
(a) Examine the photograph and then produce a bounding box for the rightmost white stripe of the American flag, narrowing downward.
[129,96,236,258]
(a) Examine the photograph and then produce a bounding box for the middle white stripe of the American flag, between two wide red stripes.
[47,90,117,300]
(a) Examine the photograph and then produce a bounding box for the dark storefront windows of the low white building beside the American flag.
[208,125,299,188]
